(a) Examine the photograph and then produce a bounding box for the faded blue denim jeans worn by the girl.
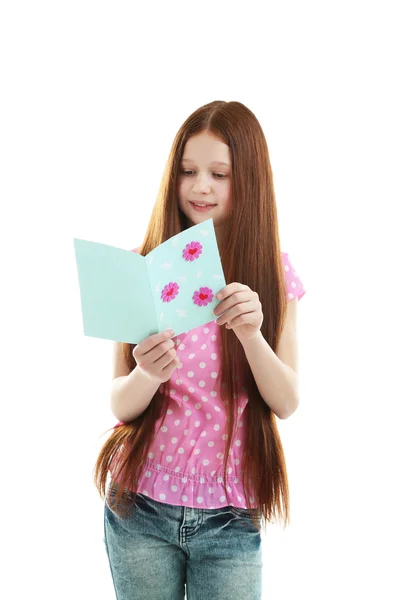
[104,482,263,600]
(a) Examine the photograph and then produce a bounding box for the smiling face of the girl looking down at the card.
[178,131,231,230]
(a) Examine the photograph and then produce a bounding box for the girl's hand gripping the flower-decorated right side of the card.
[214,282,264,343]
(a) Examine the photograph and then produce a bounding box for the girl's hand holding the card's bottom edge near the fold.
[132,329,179,383]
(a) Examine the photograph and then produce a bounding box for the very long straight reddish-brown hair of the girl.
[94,101,290,528]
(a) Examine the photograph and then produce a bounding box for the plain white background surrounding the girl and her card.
[0,0,400,600]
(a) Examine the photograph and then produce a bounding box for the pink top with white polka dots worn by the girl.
[111,252,306,509]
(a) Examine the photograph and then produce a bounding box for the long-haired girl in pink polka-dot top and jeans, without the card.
[94,101,305,600]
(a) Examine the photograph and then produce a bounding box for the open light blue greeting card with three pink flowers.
[74,218,226,344]
